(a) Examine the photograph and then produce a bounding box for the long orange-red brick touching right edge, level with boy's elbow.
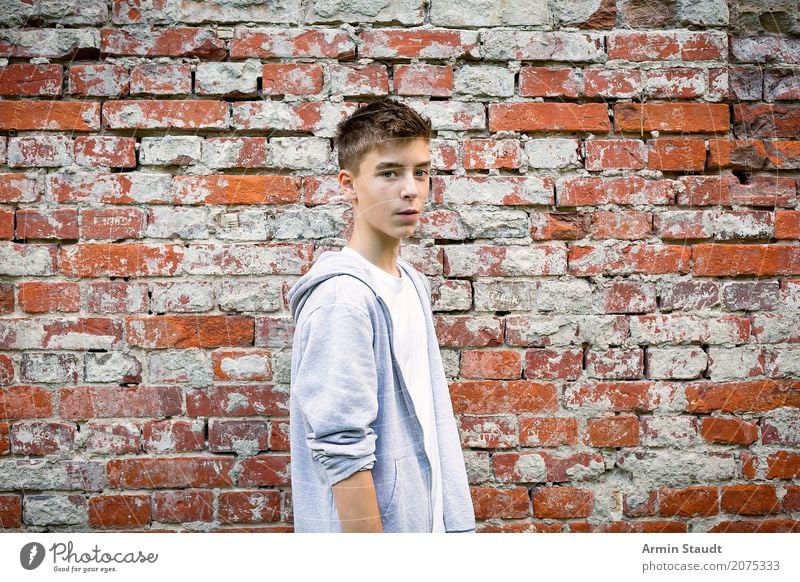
[686,380,800,414]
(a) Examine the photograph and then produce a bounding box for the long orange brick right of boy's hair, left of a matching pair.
[489,103,611,132]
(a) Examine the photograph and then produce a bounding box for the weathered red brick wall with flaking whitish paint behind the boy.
[0,0,800,531]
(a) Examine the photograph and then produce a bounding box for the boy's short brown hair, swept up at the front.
[334,98,432,175]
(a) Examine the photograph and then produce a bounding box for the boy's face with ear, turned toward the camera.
[338,138,430,244]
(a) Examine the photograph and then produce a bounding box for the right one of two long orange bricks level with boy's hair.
[614,103,730,135]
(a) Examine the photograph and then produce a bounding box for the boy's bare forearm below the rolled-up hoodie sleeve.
[333,471,383,533]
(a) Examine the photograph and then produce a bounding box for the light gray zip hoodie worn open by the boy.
[289,251,475,532]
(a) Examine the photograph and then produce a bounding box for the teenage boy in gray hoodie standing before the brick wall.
[289,99,475,532]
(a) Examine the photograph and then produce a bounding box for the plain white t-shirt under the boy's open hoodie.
[342,247,445,533]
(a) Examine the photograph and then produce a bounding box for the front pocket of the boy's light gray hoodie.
[382,454,430,532]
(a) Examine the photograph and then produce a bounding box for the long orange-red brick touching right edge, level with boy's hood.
[692,243,800,277]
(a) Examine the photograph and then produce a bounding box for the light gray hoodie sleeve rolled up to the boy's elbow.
[291,303,378,486]
